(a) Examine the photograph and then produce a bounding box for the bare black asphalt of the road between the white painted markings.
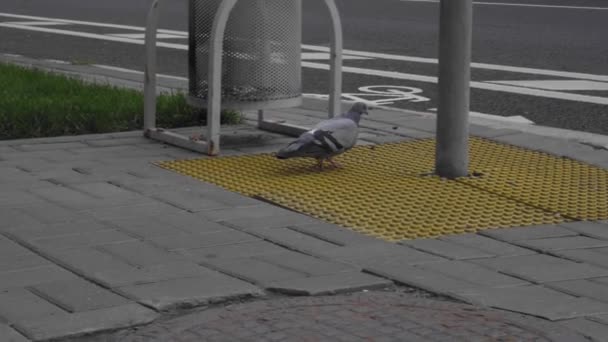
[0,0,608,134]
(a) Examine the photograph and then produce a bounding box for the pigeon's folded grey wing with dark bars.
[277,118,359,159]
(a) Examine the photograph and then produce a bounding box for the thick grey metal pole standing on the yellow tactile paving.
[435,0,473,178]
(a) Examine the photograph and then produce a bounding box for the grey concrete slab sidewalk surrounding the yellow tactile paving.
[0,56,608,341]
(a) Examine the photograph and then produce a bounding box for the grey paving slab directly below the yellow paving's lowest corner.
[318,242,448,266]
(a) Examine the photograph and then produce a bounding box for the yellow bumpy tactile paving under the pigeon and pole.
[159,138,608,241]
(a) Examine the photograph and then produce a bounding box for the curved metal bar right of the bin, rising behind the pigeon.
[325,0,343,118]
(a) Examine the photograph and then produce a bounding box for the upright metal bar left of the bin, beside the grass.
[144,0,160,134]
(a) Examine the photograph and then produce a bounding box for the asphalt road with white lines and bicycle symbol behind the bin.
[0,0,608,134]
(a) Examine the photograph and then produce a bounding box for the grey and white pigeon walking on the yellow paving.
[276,102,368,170]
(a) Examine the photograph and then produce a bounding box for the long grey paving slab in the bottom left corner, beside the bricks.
[16,304,158,341]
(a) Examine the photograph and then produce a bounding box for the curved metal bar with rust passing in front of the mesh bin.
[207,0,238,156]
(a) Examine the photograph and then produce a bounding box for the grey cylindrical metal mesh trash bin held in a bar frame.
[189,0,302,110]
